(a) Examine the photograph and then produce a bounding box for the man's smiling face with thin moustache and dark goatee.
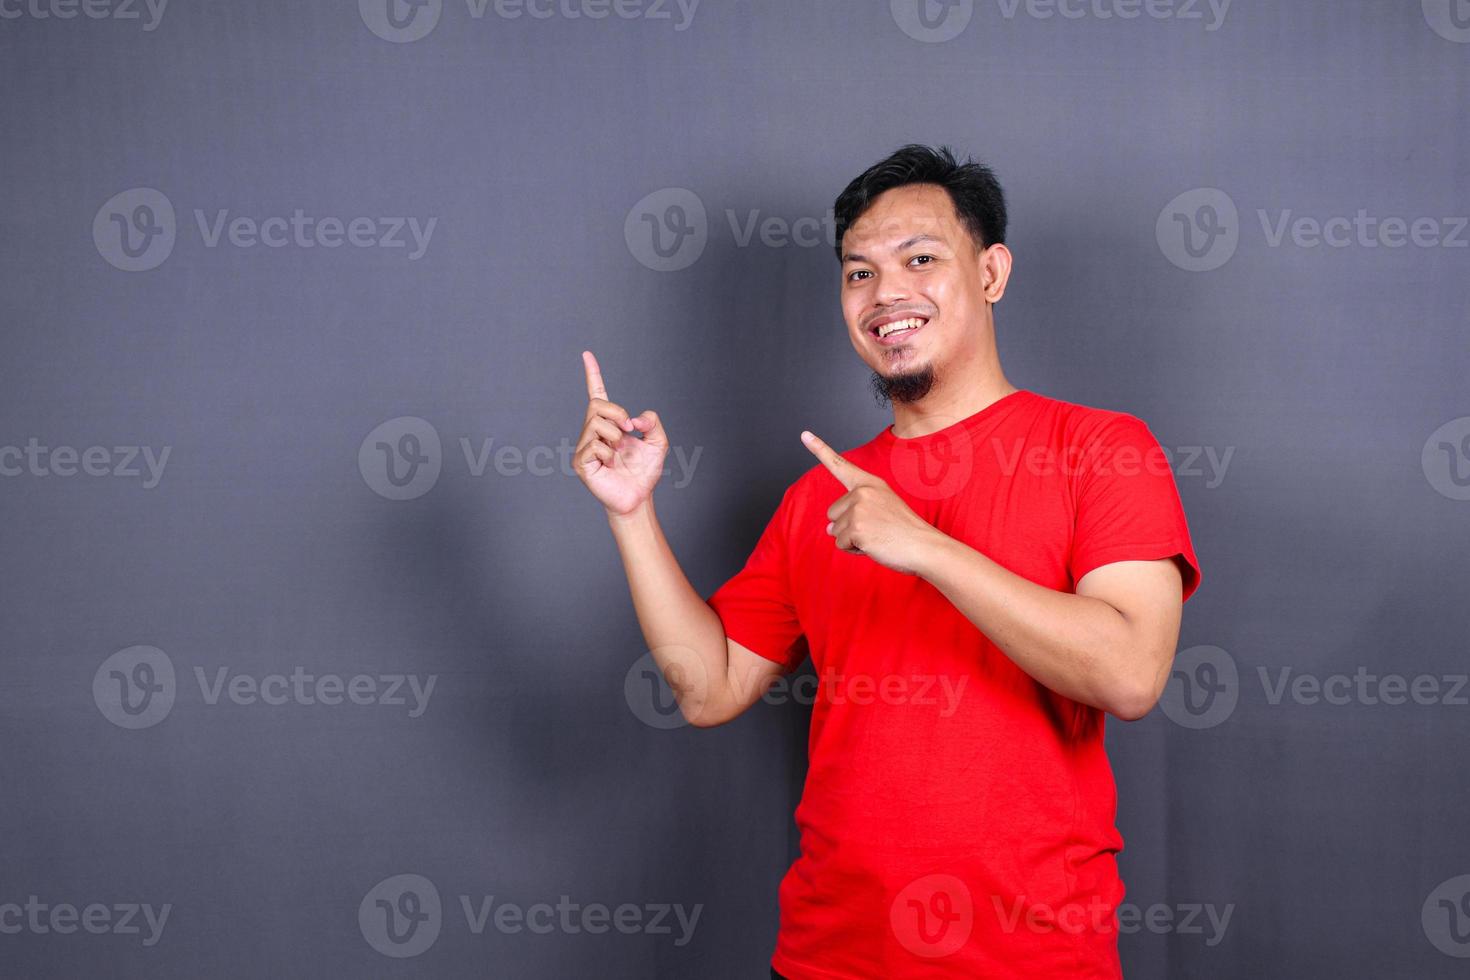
[842,184,985,401]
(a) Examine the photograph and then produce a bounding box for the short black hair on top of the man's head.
[832,143,1005,262]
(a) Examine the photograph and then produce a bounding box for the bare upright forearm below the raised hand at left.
[607,498,729,721]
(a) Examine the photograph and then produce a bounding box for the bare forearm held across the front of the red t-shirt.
[916,530,1157,718]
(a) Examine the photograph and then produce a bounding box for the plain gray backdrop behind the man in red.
[0,0,1470,979]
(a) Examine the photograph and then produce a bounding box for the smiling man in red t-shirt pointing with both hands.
[575,145,1200,980]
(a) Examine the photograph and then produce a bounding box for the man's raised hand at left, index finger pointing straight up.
[572,351,669,516]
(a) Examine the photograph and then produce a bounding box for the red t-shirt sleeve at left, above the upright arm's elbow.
[709,485,806,670]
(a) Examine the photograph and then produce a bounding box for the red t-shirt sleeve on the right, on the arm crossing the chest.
[1069,414,1200,601]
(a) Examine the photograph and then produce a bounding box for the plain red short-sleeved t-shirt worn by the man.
[709,389,1200,980]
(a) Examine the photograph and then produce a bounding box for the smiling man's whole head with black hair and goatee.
[832,144,1010,401]
